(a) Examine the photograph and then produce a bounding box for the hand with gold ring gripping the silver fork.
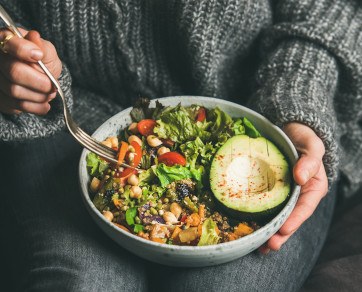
[0,28,62,115]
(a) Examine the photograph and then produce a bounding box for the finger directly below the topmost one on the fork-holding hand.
[0,55,54,93]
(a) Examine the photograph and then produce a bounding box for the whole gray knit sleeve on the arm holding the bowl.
[252,0,362,182]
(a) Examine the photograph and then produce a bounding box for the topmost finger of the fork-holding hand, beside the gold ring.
[0,30,44,62]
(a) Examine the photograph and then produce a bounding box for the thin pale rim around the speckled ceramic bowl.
[78,95,300,251]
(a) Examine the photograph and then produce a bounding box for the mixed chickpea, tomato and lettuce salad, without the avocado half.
[86,99,272,246]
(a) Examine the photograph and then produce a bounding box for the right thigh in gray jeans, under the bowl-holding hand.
[147,185,335,292]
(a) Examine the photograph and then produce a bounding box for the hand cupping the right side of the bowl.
[259,123,328,254]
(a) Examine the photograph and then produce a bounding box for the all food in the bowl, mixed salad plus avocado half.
[87,99,290,246]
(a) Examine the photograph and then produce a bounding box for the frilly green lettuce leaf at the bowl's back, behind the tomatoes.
[153,105,211,143]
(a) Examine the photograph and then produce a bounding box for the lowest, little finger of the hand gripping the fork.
[0,95,50,115]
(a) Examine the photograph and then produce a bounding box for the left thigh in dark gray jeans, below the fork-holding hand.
[0,133,145,291]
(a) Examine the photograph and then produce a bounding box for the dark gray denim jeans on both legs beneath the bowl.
[0,133,335,292]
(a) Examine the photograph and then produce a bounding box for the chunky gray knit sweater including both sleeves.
[0,0,362,195]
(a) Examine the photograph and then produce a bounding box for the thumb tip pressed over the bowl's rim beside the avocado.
[293,154,322,185]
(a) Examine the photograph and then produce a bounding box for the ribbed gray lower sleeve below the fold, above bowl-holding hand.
[251,39,338,185]
